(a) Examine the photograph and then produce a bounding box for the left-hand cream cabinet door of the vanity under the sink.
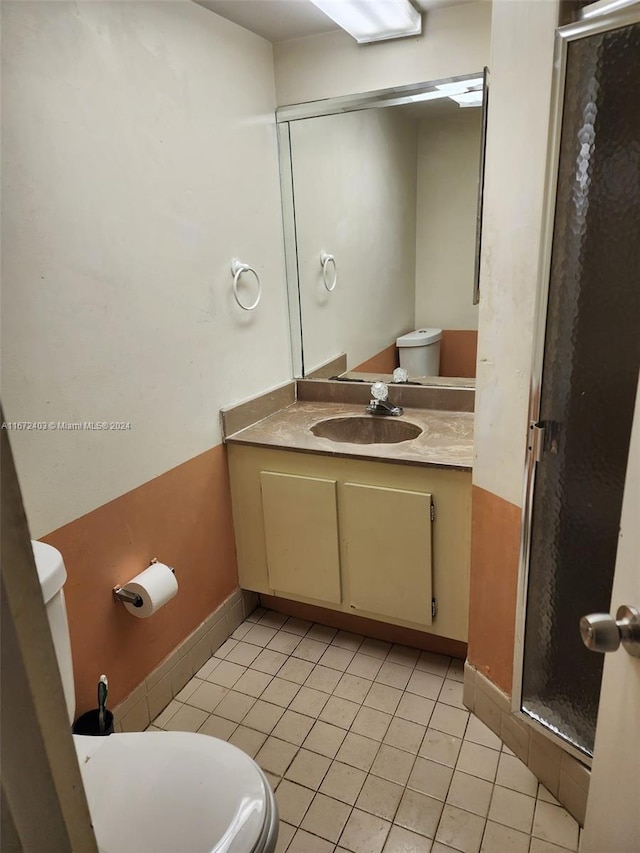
[260,471,342,604]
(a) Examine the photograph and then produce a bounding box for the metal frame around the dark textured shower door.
[511,0,640,767]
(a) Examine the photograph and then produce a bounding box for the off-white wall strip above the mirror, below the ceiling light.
[274,0,490,105]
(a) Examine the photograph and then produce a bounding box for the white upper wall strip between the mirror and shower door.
[473,0,558,506]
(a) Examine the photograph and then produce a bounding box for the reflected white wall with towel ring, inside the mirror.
[291,109,417,372]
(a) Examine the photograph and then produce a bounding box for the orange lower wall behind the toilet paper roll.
[42,445,238,715]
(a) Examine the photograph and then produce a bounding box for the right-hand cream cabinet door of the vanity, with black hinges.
[339,483,432,625]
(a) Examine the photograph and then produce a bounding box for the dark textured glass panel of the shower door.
[522,20,640,753]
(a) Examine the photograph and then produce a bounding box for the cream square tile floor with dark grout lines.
[150,609,579,853]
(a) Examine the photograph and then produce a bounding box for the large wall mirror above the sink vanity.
[277,72,486,381]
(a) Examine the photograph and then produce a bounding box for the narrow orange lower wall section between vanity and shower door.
[468,486,521,694]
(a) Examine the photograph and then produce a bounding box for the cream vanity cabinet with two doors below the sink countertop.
[227,444,471,642]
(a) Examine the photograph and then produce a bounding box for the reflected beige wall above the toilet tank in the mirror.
[416,108,482,329]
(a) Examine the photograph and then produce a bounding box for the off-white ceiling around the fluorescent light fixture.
[195,0,478,42]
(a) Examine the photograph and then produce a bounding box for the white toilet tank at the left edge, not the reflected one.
[31,541,76,723]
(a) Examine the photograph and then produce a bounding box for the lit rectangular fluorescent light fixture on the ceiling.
[311,0,422,44]
